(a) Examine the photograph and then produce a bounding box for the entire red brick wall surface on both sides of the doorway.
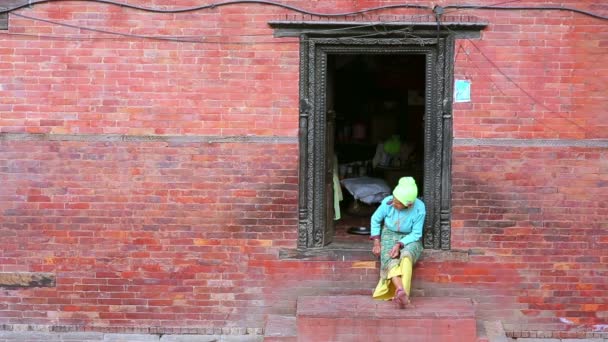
[0,0,608,331]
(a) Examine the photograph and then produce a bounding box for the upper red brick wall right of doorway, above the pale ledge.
[454,10,608,139]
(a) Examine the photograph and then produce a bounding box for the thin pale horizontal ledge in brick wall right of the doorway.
[453,138,608,148]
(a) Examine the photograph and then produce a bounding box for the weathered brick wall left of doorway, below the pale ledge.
[0,141,297,326]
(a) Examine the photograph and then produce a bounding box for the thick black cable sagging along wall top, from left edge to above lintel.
[0,0,431,17]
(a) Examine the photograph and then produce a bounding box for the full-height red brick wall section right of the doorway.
[446,2,608,331]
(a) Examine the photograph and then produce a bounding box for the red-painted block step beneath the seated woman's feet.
[296,296,477,342]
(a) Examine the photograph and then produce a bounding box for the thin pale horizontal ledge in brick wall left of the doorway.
[0,133,298,144]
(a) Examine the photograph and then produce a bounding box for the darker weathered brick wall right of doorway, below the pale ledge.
[448,146,608,330]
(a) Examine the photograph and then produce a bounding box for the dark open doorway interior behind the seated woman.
[326,54,427,242]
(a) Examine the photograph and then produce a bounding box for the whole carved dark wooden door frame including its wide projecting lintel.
[268,20,487,250]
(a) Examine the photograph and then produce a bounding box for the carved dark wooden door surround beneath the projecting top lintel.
[298,28,454,249]
